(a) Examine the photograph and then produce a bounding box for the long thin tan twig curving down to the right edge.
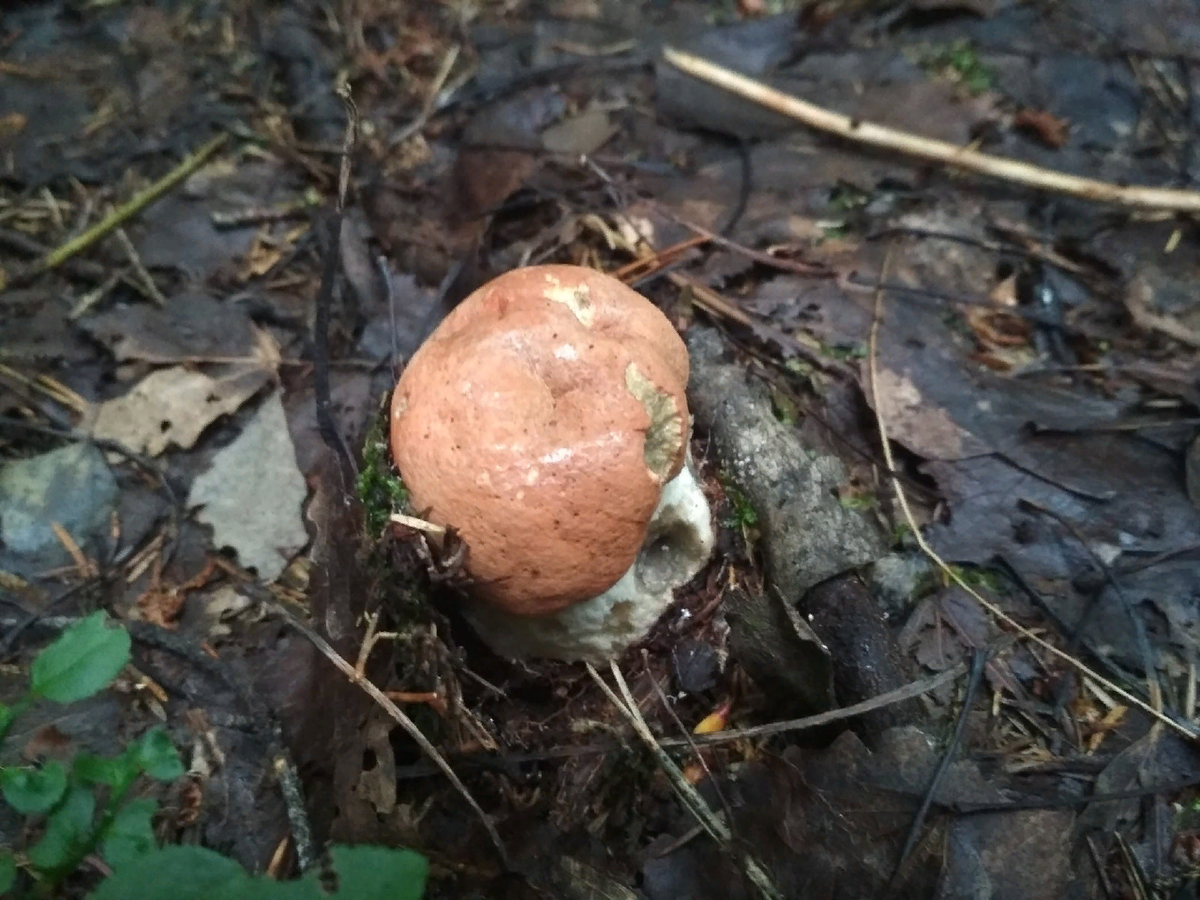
[868,246,1200,740]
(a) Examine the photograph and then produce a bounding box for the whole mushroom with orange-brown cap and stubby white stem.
[391,265,713,661]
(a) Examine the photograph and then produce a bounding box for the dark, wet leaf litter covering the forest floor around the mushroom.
[0,0,1200,900]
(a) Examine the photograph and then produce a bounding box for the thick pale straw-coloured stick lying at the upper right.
[662,47,1200,212]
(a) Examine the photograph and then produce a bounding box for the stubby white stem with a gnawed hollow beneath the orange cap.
[463,460,713,664]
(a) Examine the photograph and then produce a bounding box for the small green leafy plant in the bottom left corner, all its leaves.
[0,612,428,900]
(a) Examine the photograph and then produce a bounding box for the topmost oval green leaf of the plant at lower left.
[29,612,130,703]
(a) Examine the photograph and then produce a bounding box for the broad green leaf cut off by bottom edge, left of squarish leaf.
[91,846,253,900]
